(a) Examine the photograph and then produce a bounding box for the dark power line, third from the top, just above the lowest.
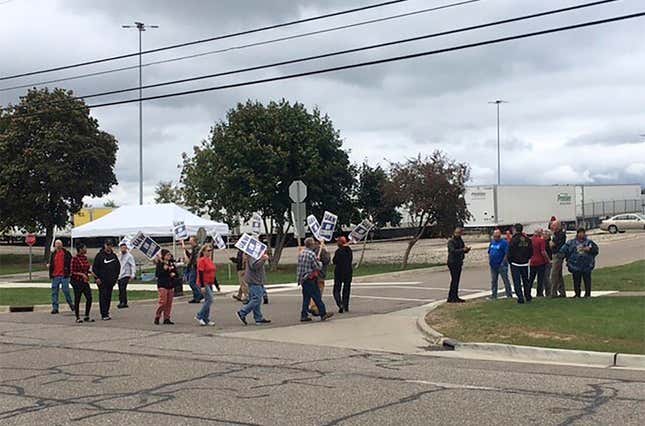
[69,0,618,99]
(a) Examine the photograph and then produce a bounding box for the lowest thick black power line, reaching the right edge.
[4,12,645,118]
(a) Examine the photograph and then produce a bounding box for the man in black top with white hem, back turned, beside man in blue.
[508,223,533,303]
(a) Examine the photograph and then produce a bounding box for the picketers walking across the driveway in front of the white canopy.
[48,236,353,326]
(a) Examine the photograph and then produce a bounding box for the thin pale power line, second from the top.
[0,0,480,92]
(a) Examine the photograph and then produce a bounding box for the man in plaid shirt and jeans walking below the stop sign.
[296,237,334,322]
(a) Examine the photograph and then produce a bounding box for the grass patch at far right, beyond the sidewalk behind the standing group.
[565,260,645,291]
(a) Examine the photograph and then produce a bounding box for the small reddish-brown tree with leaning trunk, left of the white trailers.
[388,151,470,268]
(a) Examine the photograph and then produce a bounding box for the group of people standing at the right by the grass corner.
[447,217,598,304]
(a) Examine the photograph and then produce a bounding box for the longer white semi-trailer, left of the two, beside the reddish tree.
[465,185,576,233]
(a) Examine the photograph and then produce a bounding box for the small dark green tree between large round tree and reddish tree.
[356,161,401,269]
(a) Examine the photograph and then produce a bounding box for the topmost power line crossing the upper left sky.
[0,0,409,81]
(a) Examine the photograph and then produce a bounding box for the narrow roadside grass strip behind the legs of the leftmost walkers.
[0,288,158,309]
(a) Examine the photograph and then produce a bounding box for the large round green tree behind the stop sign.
[181,100,355,267]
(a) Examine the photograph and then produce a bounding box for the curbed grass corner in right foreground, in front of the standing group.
[426,296,645,354]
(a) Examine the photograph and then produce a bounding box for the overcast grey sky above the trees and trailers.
[0,0,645,205]
